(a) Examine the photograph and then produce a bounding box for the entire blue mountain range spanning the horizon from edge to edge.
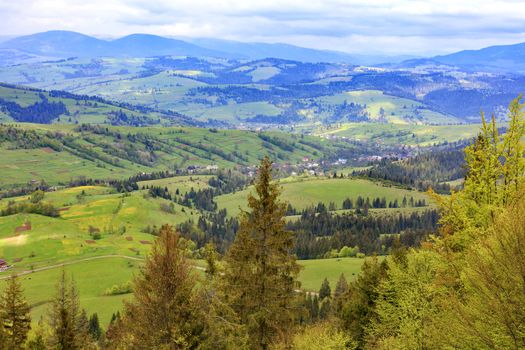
[0,30,525,73]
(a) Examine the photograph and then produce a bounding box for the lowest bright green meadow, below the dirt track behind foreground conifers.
[0,257,364,327]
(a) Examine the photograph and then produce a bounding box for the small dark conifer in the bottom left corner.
[0,275,31,349]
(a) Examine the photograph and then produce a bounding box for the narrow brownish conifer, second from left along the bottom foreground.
[49,270,86,350]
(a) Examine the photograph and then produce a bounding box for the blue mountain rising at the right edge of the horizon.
[433,43,525,73]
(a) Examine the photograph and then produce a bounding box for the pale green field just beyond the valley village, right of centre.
[318,123,480,146]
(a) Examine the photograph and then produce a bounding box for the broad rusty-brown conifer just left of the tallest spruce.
[117,225,203,349]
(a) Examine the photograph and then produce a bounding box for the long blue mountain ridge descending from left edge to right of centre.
[0,30,406,65]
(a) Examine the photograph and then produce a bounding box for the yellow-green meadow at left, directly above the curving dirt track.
[0,187,197,271]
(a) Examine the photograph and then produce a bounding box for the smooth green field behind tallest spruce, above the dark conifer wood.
[216,178,429,215]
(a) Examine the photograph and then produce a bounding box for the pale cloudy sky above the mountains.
[0,0,525,56]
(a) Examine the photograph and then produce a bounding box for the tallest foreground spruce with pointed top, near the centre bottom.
[222,157,300,349]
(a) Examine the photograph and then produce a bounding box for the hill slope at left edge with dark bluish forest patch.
[0,83,201,126]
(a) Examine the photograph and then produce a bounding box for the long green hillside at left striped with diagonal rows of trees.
[0,124,344,186]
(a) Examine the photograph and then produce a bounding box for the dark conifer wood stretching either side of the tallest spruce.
[178,203,439,259]
